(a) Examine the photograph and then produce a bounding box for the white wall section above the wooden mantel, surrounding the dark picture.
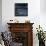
[2,0,40,31]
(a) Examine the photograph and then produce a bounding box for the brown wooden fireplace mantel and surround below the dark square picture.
[7,23,33,46]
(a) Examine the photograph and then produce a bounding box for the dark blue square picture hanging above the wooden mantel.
[15,3,28,16]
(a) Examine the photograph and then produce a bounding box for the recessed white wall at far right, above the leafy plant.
[40,0,46,31]
